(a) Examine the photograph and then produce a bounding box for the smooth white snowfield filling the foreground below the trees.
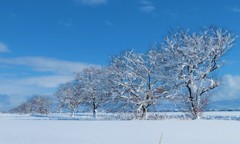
[0,114,240,144]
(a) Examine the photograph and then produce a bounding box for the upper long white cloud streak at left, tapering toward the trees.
[0,57,96,74]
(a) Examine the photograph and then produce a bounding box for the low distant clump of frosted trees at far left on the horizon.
[10,95,51,114]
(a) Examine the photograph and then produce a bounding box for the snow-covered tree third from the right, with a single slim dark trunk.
[75,67,111,118]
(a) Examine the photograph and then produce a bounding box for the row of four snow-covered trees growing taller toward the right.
[9,28,236,119]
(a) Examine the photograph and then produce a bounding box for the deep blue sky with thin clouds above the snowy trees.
[0,0,240,109]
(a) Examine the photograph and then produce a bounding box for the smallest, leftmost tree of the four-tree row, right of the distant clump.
[54,81,84,116]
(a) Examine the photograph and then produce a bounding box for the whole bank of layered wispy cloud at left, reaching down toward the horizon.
[0,57,97,105]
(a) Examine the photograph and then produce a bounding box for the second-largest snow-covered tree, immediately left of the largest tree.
[109,51,167,119]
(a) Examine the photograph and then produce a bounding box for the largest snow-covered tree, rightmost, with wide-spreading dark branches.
[156,28,235,119]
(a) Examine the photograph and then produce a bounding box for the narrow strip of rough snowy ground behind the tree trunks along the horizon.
[0,111,240,121]
